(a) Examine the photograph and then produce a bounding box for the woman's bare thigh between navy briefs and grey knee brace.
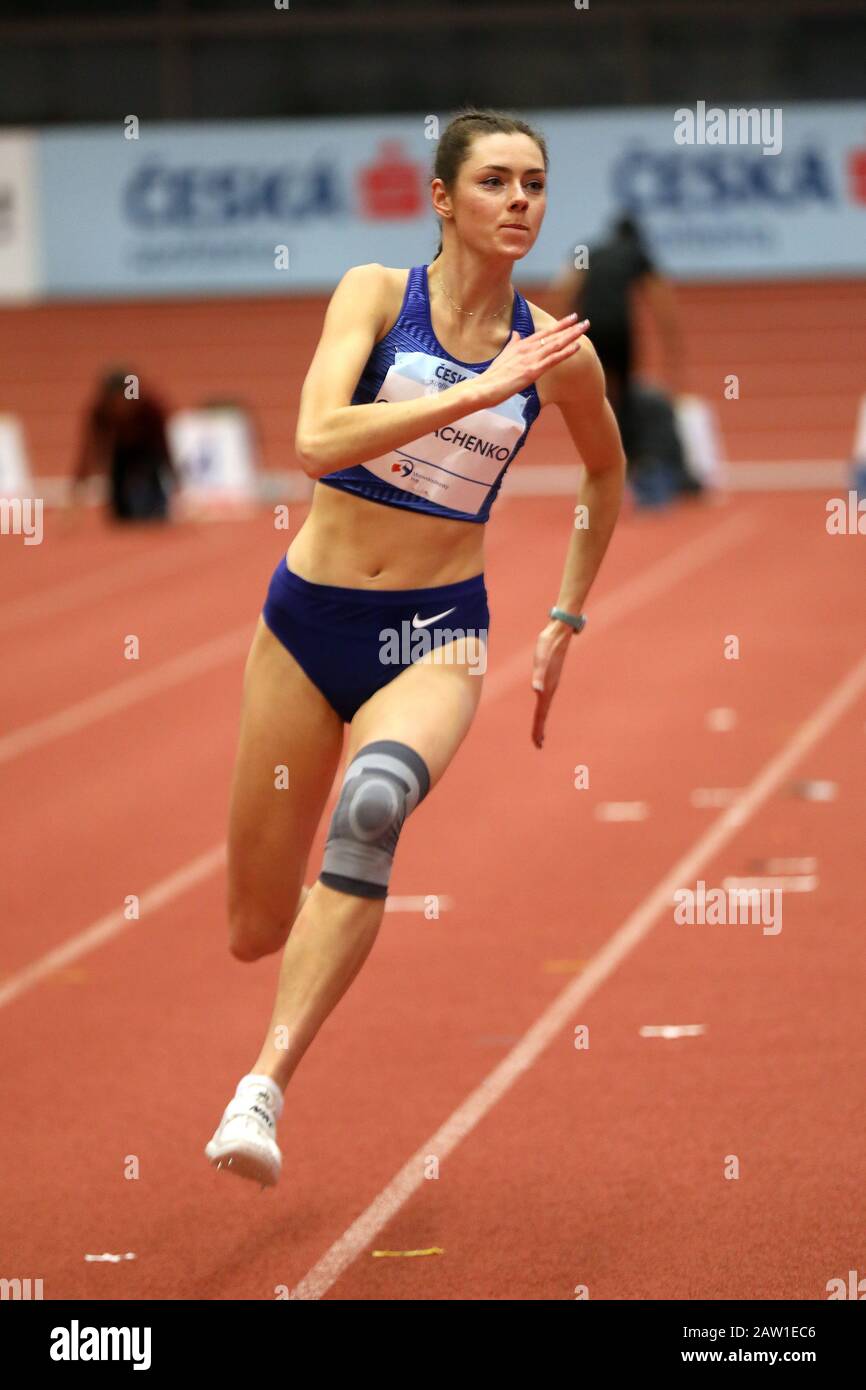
[346,637,484,788]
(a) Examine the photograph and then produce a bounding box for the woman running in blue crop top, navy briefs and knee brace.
[206,110,626,1187]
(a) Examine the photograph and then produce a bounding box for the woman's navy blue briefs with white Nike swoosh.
[261,555,491,724]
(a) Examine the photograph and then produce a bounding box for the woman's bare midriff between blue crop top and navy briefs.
[288,484,484,589]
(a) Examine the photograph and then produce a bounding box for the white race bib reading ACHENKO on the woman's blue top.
[364,352,525,514]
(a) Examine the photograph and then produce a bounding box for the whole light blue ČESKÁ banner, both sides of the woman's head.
[38,101,866,296]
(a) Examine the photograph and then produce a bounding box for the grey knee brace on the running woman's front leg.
[318,738,430,898]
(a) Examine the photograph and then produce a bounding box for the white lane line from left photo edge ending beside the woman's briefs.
[0,620,256,763]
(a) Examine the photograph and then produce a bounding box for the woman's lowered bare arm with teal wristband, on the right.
[532,338,626,748]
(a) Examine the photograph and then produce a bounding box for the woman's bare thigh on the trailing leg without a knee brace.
[228,617,343,920]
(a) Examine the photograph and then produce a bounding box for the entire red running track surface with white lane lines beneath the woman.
[0,483,866,1300]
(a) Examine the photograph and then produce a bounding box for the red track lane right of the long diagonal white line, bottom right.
[318,695,866,1301]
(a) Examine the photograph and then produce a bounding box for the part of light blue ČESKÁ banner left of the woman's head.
[42,118,438,295]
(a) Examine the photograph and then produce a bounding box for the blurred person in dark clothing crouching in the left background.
[72,368,178,521]
